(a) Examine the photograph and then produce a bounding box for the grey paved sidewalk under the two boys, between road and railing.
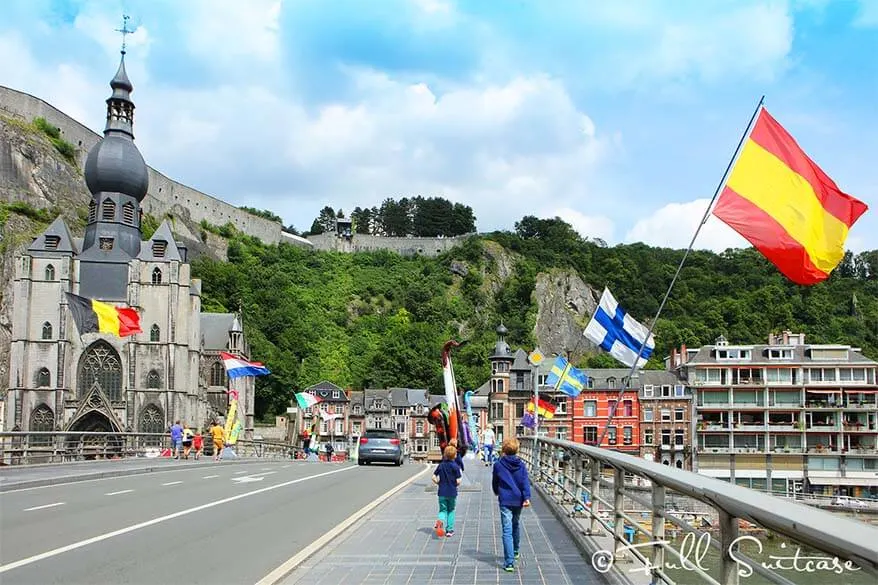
[283,461,604,585]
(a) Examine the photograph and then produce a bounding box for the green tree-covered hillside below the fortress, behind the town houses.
[194,217,878,416]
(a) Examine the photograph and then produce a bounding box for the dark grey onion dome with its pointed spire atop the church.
[85,53,149,201]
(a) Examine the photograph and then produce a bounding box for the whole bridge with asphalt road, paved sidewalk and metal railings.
[0,433,878,585]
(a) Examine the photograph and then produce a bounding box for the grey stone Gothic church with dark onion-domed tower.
[0,51,254,437]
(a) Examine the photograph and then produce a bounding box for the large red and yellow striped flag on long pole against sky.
[713,109,868,285]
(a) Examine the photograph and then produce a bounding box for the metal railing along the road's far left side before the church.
[0,431,301,465]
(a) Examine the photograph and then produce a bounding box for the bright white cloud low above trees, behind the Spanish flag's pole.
[625,199,750,252]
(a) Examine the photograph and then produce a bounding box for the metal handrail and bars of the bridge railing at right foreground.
[519,437,878,583]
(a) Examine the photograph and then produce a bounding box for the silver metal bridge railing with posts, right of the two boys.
[519,437,878,585]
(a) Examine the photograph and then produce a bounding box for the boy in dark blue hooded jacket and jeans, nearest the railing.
[491,438,530,573]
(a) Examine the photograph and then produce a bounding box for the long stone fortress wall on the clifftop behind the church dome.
[0,86,281,244]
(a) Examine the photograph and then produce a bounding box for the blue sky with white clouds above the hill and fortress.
[0,0,878,251]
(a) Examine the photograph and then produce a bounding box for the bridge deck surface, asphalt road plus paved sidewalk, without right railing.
[0,460,603,585]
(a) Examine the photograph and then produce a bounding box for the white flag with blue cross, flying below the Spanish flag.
[583,288,655,368]
